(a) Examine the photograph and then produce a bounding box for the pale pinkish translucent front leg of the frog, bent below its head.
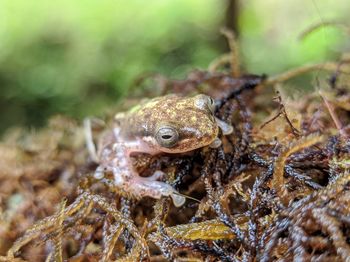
[96,141,185,206]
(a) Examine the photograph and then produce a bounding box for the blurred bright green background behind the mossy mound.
[0,0,350,134]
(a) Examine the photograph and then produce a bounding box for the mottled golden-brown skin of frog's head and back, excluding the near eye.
[117,95,219,153]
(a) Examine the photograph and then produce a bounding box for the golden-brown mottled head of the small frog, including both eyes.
[147,95,219,153]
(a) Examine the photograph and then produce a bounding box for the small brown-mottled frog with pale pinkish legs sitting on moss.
[85,94,233,207]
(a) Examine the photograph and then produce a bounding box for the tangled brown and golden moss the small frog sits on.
[0,48,350,261]
